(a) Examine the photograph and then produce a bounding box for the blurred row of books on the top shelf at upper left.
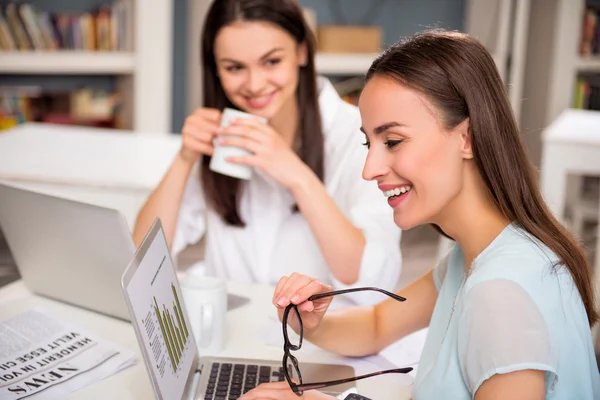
[0,0,133,51]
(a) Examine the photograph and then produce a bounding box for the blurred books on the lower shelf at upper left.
[0,86,121,129]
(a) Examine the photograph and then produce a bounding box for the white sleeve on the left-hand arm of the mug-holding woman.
[172,164,206,255]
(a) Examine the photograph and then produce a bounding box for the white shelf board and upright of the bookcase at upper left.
[0,0,174,134]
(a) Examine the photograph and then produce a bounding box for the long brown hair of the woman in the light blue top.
[366,31,598,326]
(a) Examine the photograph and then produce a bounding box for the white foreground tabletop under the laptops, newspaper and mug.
[0,281,411,400]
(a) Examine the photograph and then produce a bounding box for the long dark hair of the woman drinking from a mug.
[201,0,324,227]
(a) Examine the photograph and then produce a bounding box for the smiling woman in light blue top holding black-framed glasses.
[242,31,600,400]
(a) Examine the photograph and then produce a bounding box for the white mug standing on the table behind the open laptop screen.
[180,275,227,356]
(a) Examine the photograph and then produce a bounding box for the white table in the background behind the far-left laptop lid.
[0,123,181,227]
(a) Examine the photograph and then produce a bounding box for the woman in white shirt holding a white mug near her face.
[134,0,401,302]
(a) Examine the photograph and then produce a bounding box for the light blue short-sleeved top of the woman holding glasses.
[407,224,600,400]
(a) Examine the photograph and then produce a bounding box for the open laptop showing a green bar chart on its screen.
[121,219,354,400]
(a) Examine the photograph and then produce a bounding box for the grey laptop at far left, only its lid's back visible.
[0,184,135,320]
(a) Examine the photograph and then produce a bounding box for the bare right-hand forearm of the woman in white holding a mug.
[290,168,366,285]
